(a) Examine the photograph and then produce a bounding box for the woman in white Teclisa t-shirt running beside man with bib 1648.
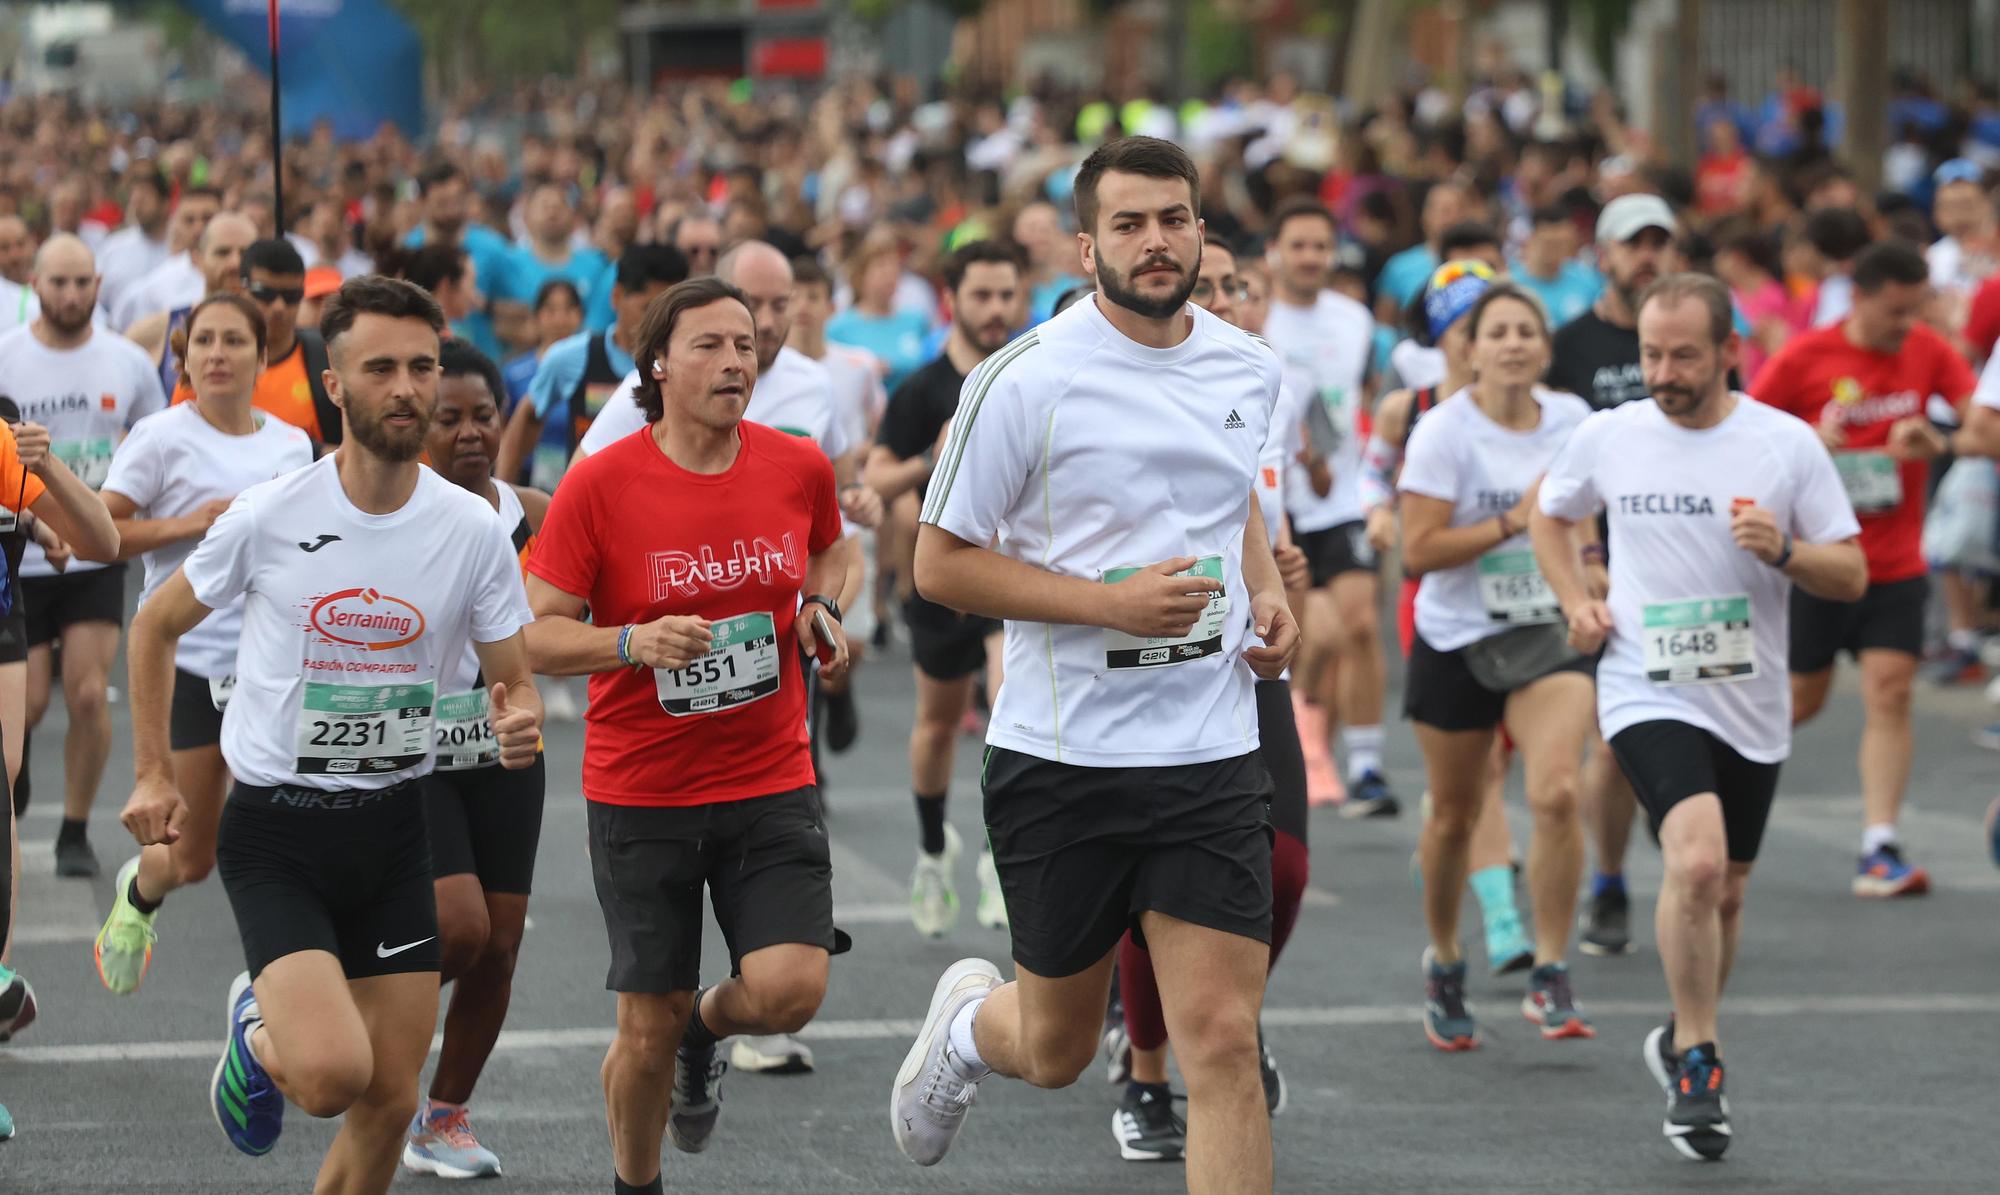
[1400,284,1594,1049]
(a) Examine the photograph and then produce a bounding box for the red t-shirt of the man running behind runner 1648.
[1750,324,1976,584]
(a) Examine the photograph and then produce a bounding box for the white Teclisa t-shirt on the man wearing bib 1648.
[1544,396,1860,763]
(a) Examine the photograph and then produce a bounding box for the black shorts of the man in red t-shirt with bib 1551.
[588,785,834,993]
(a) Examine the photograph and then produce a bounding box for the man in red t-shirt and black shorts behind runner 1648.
[1750,242,1974,897]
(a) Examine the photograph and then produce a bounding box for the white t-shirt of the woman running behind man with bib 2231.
[104,402,312,679]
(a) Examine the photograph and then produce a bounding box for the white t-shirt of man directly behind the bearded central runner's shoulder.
[1264,290,1374,532]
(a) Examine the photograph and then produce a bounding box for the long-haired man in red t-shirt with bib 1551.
[528,278,850,1191]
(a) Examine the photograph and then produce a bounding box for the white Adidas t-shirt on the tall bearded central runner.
[922,302,1282,767]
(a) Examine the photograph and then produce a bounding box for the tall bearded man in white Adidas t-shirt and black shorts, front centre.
[890,138,1298,1191]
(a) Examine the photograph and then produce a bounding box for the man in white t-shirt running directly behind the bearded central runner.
[1264,200,1398,817]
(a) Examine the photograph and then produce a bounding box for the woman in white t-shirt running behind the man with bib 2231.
[92,294,312,995]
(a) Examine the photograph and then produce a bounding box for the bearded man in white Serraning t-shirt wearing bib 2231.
[124,276,542,1193]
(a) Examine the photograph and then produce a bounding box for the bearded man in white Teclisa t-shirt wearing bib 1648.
[1530,274,1868,1159]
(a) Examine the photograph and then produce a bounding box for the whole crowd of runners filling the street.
[0,63,2000,1191]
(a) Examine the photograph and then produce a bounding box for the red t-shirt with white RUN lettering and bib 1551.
[528,422,840,805]
